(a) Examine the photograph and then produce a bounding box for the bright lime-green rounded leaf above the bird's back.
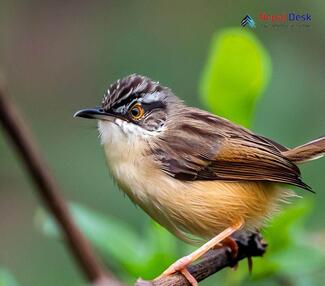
[199,28,271,126]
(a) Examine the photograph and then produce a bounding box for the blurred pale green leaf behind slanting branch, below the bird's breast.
[35,203,176,278]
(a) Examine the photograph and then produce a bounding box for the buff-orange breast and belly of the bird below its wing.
[104,147,293,244]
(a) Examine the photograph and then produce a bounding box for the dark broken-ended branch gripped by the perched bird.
[136,233,266,286]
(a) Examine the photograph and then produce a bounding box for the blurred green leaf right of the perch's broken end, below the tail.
[254,199,325,278]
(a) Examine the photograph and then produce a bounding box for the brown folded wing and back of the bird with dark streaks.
[152,109,311,190]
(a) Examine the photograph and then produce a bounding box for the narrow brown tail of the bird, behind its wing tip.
[282,136,325,163]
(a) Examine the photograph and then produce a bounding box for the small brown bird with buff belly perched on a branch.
[75,74,325,285]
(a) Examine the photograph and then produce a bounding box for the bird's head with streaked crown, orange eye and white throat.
[74,74,182,144]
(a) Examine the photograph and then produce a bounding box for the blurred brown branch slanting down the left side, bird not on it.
[0,82,122,286]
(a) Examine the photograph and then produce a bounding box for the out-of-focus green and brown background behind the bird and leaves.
[0,0,325,286]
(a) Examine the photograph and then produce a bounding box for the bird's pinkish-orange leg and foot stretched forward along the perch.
[160,221,244,286]
